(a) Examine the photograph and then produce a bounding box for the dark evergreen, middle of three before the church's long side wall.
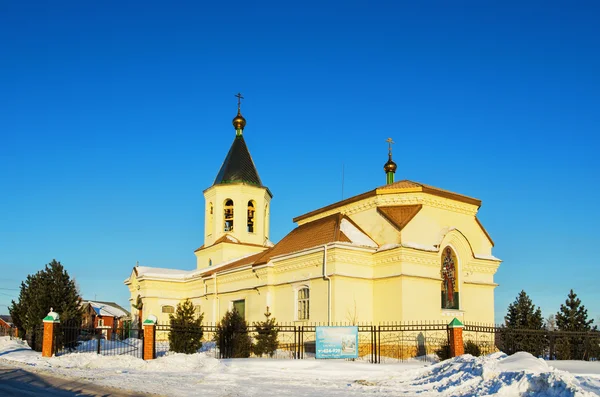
[215,309,252,358]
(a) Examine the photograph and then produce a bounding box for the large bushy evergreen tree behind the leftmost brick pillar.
[9,260,83,348]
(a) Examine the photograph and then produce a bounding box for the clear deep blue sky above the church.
[0,1,600,321]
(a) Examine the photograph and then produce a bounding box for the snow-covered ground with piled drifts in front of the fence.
[0,337,600,397]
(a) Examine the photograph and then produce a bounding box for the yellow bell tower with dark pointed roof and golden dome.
[196,94,273,268]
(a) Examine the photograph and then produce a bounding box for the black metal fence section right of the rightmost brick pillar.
[463,324,600,361]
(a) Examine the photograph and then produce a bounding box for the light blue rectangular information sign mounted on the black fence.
[316,327,358,358]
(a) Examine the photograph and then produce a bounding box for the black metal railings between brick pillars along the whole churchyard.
[17,322,600,363]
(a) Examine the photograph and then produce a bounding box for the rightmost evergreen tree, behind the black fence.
[555,290,598,360]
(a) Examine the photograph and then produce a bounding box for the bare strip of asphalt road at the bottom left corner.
[0,364,155,397]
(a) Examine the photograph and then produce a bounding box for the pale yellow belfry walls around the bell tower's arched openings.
[204,183,271,247]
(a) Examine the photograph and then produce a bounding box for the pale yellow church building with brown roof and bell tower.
[125,98,500,324]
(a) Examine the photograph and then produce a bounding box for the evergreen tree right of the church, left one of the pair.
[501,291,546,356]
